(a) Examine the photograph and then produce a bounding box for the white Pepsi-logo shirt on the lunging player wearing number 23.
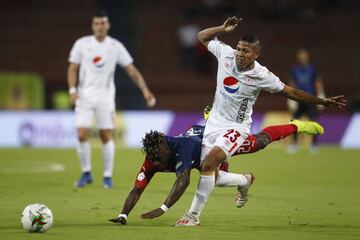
[205,39,284,133]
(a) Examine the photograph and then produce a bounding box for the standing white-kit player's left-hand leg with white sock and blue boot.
[75,128,93,188]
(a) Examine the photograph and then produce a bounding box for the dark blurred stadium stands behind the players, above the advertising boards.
[0,0,360,112]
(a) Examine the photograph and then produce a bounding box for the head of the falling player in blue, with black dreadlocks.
[141,131,166,161]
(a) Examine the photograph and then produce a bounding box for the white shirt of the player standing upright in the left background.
[69,36,133,102]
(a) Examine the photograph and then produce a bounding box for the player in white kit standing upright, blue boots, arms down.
[67,12,155,188]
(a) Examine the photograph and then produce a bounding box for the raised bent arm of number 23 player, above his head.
[198,16,242,47]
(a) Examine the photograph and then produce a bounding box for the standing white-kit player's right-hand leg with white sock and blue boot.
[100,129,115,188]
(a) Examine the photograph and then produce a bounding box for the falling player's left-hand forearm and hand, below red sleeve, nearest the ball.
[109,186,144,225]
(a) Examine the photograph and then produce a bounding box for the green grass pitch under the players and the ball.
[0,147,360,240]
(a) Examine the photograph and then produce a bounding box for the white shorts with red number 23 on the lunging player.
[200,127,248,162]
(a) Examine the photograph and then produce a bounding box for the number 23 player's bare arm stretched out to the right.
[280,85,346,108]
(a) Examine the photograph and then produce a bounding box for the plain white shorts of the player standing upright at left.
[75,99,115,129]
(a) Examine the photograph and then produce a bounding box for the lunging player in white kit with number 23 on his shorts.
[175,17,346,226]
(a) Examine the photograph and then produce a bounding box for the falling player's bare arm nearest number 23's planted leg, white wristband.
[141,169,191,219]
